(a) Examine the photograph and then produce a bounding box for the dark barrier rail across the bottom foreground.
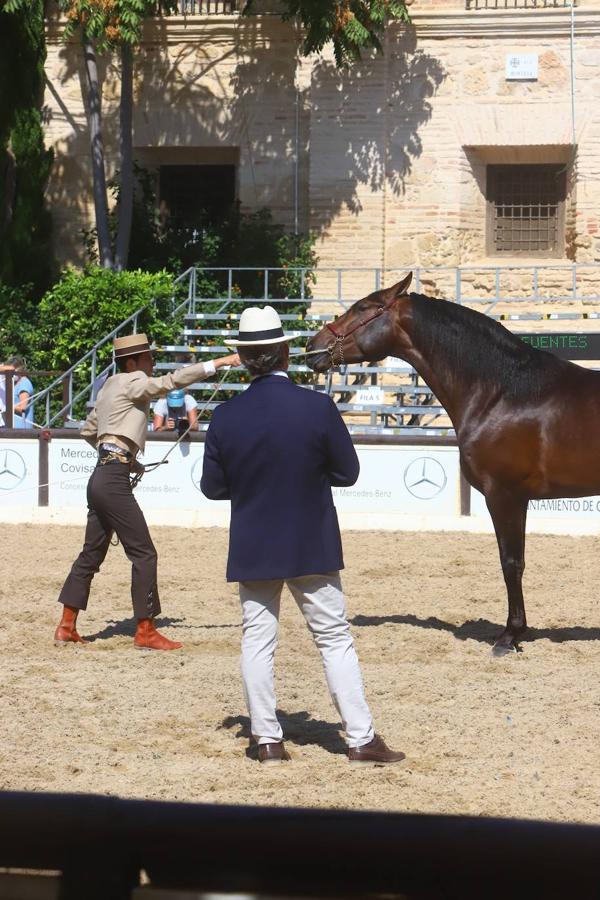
[0,796,600,900]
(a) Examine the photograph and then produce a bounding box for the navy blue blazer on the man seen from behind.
[200,375,359,581]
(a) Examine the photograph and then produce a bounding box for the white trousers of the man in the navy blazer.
[240,572,375,747]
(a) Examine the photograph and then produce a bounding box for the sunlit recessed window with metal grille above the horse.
[487,164,566,256]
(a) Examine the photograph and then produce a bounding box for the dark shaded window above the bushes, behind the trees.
[159,165,235,228]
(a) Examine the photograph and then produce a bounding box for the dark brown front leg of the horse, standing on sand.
[485,492,527,656]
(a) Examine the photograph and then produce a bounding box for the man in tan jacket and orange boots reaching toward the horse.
[54,334,239,650]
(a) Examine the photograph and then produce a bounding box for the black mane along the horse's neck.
[410,293,564,401]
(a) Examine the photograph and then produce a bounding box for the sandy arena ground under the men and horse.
[0,525,600,822]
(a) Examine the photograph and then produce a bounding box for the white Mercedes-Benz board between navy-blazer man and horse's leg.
[333,446,460,516]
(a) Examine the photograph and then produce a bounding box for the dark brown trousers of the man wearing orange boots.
[58,462,160,619]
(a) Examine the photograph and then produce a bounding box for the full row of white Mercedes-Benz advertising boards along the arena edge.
[9,437,600,535]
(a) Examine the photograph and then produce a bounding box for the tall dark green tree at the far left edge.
[0,0,52,293]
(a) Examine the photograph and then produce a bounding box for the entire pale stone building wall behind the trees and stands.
[46,0,600,296]
